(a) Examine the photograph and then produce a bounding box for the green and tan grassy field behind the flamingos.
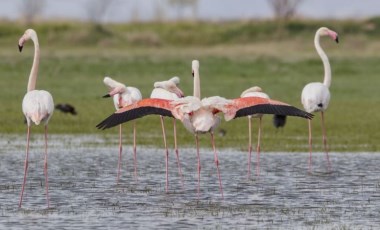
[0,18,380,152]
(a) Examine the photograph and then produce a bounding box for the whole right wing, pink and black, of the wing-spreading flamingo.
[224,97,314,121]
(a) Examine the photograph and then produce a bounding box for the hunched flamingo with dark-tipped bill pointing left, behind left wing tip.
[103,76,142,183]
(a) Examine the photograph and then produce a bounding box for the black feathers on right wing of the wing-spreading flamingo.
[234,104,314,119]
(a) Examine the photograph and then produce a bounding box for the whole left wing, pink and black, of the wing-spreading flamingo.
[96,98,174,129]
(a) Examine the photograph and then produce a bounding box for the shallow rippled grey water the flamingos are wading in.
[0,136,380,229]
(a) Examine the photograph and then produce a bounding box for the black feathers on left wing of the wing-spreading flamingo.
[96,106,174,130]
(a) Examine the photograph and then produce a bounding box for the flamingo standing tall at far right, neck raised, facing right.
[301,27,339,173]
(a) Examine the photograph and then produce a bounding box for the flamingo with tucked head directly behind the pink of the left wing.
[150,76,187,192]
